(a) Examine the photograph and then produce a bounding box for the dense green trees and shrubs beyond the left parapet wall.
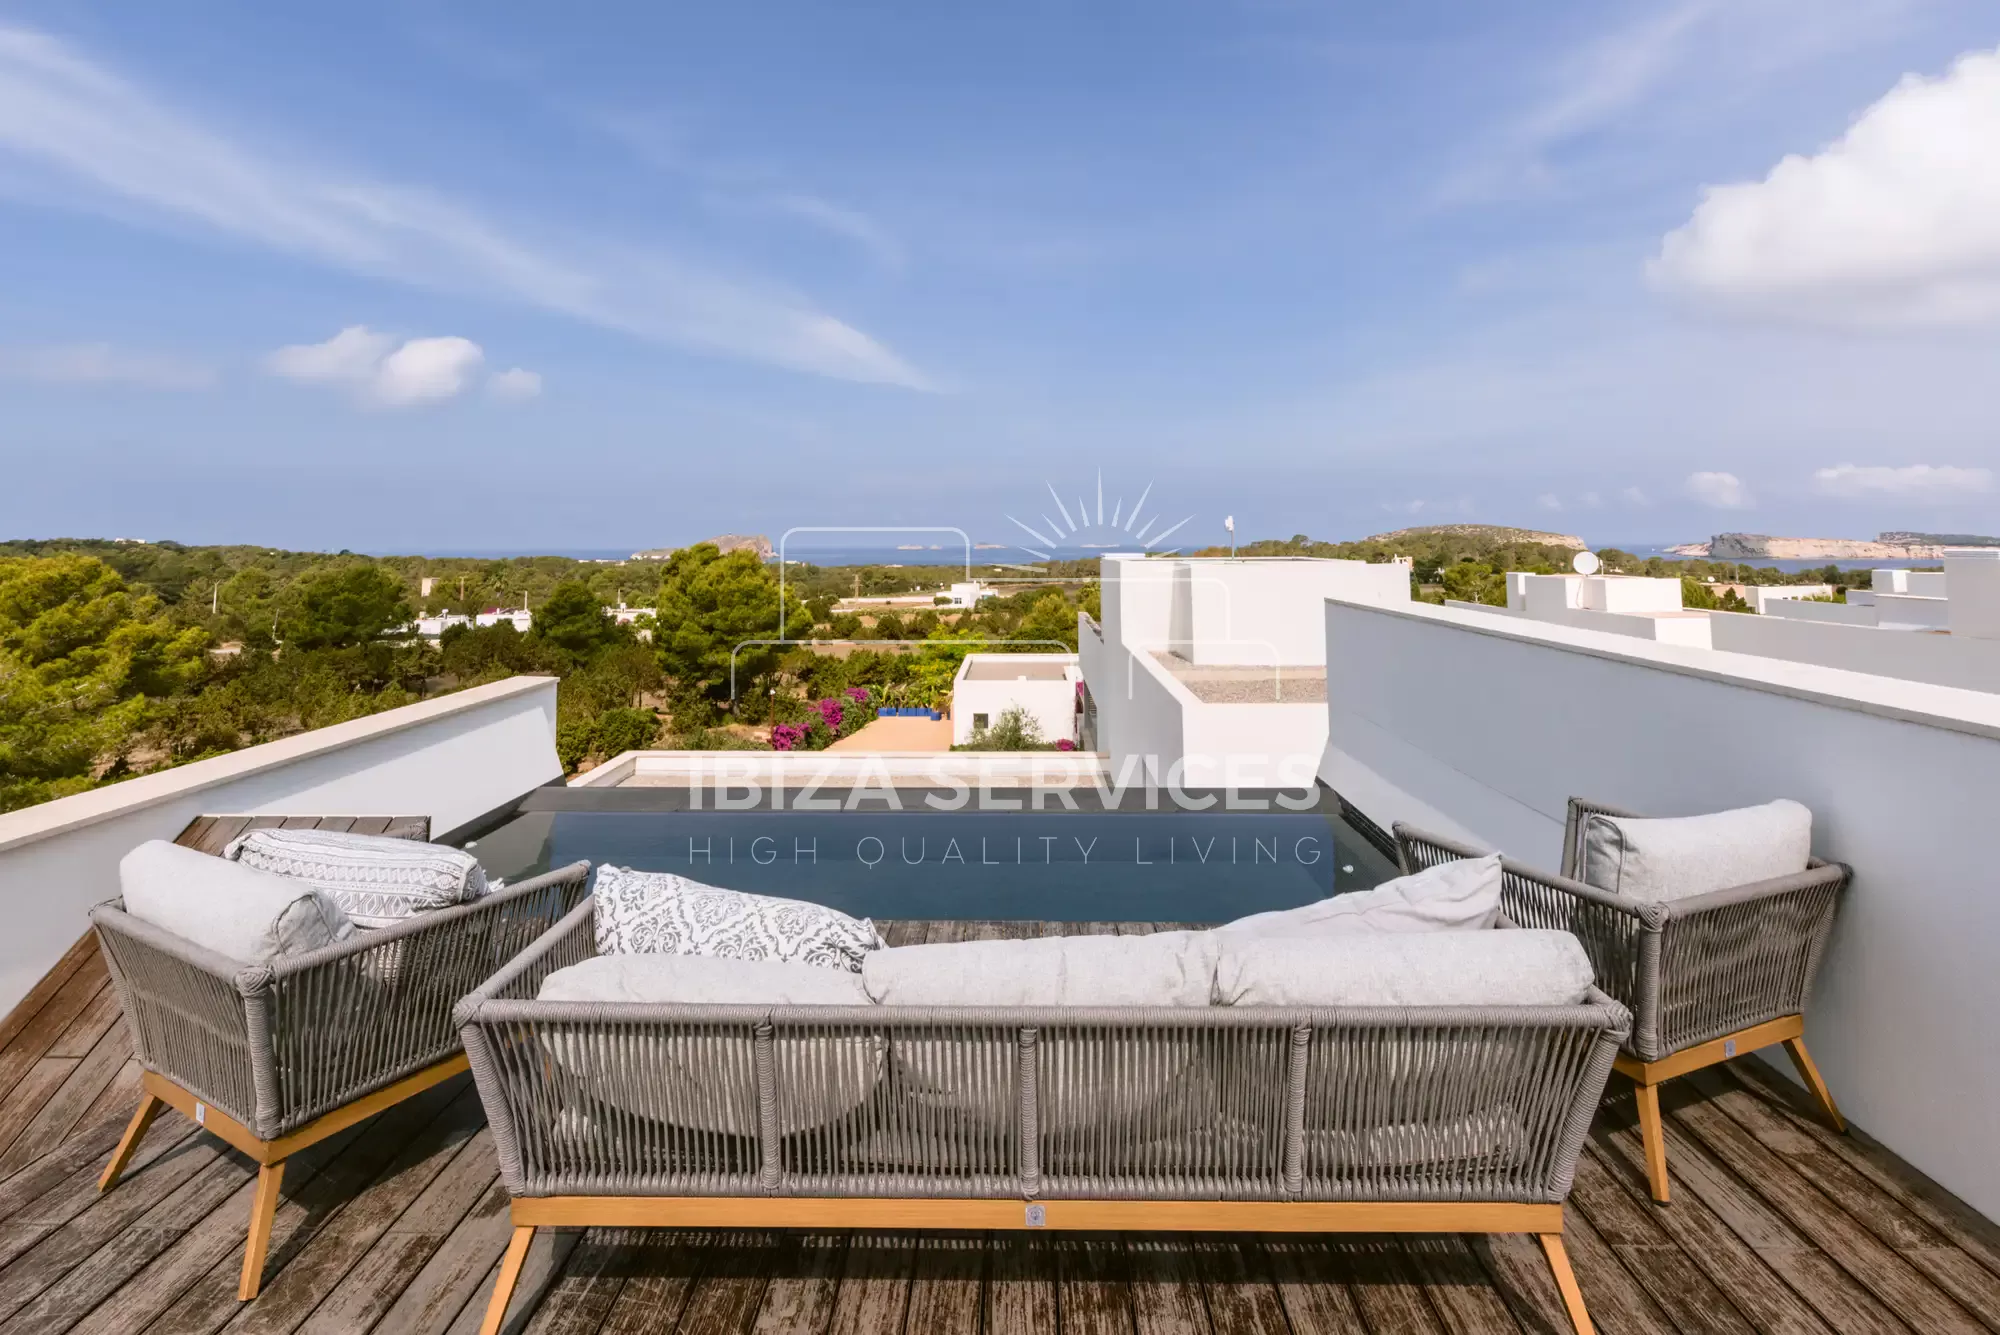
[0,542,1096,811]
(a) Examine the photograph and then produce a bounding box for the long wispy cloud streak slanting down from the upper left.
[0,26,928,388]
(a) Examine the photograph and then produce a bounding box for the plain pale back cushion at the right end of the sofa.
[1216,929,1592,1005]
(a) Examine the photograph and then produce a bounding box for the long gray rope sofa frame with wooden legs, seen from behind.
[458,875,1630,1331]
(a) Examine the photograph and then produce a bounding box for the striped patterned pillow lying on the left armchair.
[222,829,486,927]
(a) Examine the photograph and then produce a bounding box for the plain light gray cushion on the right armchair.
[1582,797,1812,903]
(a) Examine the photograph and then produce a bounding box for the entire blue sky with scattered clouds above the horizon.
[0,0,2000,550]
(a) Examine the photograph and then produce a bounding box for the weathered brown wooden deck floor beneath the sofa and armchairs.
[0,923,2000,1335]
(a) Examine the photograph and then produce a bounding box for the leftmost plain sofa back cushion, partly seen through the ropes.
[536,955,888,1137]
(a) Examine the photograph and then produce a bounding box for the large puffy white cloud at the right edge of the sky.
[1648,52,2000,326]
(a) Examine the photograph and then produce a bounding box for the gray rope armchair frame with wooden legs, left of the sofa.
[90,863,590,1301]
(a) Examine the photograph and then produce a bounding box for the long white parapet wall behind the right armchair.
[1320,600,2000,1217]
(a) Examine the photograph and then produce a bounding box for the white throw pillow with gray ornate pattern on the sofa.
[594,867,884,973]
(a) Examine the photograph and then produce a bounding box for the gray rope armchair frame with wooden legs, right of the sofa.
[1396,797,1848,1203]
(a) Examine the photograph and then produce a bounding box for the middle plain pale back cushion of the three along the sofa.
[862,931,1216,1005]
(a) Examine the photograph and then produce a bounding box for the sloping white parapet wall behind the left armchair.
[0,677,562,1013]
